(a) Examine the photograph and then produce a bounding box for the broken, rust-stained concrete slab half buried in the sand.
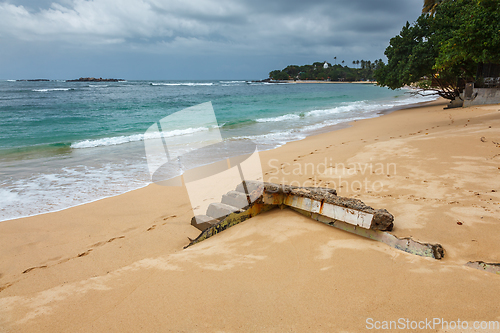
[186,181,444,259]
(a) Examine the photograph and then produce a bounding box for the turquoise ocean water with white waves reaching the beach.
[0,80,434,221]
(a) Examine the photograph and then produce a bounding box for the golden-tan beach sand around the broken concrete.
[0,101,500,332]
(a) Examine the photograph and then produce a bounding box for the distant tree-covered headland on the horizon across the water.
[269,57,383,81]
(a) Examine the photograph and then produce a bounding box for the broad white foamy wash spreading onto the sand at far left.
[0,163,149,221]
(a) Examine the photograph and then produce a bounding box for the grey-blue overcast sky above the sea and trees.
[0,0,423,80]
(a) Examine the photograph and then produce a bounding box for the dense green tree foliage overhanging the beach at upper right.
[375,0,500,99]
